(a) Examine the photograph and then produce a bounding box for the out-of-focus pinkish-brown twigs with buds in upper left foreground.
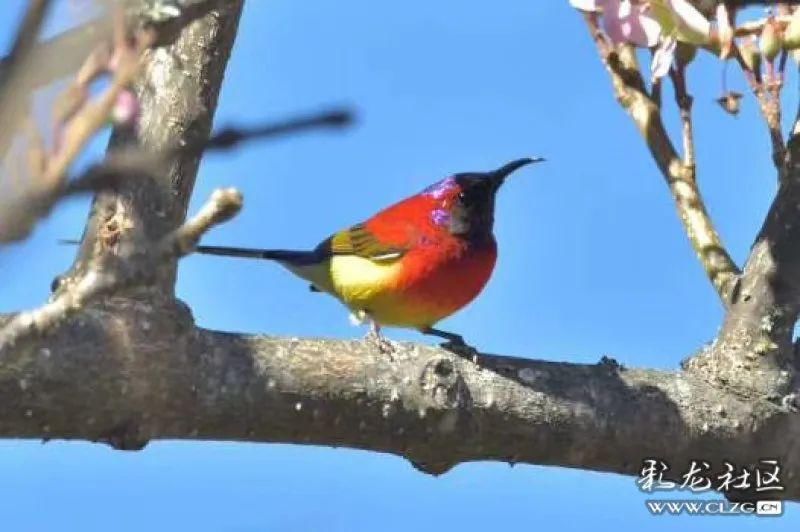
[0,0,272,246]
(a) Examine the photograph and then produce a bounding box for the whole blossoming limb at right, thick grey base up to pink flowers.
[570,0,800,394]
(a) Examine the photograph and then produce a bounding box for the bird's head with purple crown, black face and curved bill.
[424,157,544,239]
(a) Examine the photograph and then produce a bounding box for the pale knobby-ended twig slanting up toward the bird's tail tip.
[0,188,242,352]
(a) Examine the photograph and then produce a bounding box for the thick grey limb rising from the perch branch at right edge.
[688,88,800,395]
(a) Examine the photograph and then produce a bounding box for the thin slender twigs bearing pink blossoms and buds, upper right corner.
[570,0,800,306]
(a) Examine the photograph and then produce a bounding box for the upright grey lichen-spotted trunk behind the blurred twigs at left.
[68,0,247,292]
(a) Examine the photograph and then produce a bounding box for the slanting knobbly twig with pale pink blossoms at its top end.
[570,0,740,305]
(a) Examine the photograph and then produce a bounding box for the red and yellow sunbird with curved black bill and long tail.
[197,158,543,345]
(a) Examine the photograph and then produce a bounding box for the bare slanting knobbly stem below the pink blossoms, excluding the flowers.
[584,13,739,305]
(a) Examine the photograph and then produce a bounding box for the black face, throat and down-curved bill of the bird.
[450,157,544,240]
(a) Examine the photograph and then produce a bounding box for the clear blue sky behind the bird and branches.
[0,0,800,531]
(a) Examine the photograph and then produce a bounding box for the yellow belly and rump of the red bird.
[284,255,447,329]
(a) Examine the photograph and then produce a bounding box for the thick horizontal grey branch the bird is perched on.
[0,308,800,500]
